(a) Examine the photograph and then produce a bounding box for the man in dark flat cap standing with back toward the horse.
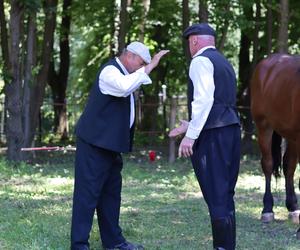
[169,23,241,250]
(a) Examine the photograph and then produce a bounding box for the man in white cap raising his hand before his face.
[71,42,168,250]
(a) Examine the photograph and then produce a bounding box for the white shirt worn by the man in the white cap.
[99,58,152,127]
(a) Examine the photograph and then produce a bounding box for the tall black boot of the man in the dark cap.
[211,216,235,250]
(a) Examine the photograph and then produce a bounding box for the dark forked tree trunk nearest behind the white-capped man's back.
[49,0,72,140]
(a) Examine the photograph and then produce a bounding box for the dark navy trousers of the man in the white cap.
[71,138,125,250]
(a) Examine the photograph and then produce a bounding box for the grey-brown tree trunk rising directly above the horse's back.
[277,0,289,53]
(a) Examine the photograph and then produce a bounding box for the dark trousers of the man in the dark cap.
[191,125,241,250]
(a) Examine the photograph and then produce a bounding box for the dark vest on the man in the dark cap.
[188,49,240,130]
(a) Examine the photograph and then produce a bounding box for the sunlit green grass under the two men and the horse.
[0,152,300,250]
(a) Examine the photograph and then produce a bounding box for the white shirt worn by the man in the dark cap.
[186,46,215,139]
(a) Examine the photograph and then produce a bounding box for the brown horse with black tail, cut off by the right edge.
[251,54,300,234]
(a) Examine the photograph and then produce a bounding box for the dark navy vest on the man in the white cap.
[76,59,134,152]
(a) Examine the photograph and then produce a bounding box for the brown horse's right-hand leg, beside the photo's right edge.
[283,142,300,224]
